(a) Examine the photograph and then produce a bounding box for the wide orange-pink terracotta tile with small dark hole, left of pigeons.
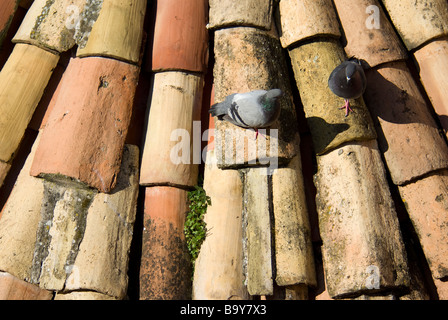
[31,57,139,192]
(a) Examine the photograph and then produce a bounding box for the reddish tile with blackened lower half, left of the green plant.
[140,187,191,300]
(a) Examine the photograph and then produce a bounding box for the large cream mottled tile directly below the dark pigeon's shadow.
[315,140,409,298]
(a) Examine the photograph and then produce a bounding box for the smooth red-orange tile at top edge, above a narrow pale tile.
[148,0,208,72]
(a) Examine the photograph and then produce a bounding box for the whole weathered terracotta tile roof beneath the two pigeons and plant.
[0,0,448,300]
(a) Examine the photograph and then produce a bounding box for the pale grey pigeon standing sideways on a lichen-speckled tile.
[209,89,283,138]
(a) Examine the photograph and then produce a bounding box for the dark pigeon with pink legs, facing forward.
[328,58,367,117]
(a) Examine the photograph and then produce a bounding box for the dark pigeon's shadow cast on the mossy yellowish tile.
[307,117,350,154]
